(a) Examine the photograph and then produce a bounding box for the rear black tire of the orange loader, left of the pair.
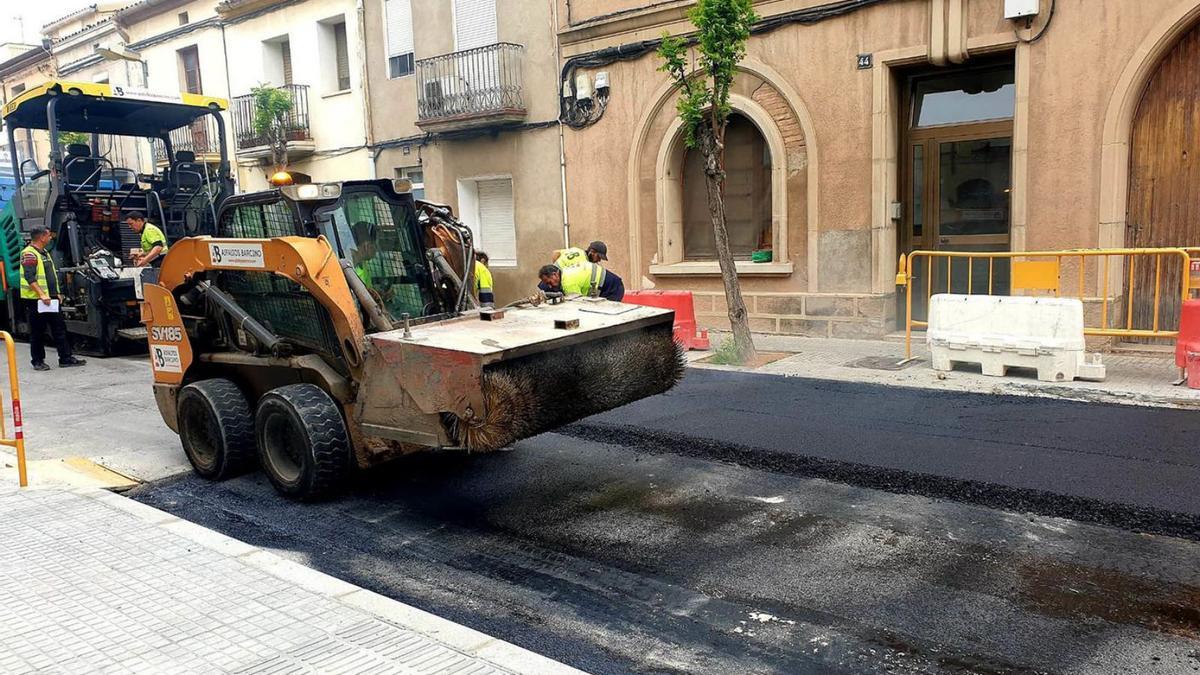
[175,378,254,480]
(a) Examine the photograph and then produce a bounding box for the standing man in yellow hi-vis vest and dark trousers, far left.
[20,227,86,370]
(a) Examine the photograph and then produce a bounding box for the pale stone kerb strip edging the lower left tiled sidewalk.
[70,488,586,675]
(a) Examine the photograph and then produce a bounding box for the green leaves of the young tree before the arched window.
[659,0,758,148]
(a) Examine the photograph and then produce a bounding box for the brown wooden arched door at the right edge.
[1126,21,1200,329]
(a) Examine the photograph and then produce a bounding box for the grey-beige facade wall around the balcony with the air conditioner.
[365,0,563,301]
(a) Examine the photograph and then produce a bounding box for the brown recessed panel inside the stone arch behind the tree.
[679,113,773,261]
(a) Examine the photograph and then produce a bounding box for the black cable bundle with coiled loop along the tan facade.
[559,0,892,129]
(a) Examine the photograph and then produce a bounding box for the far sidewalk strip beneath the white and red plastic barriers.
[688,334,1200,408]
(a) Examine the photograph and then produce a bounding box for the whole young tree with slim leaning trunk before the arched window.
[659,0,758,363]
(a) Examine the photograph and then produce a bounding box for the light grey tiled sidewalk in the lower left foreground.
[0,485,578,675]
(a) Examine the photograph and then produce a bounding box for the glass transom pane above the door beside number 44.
[912,67,1016,127]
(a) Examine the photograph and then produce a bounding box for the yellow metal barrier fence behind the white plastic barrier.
[896,249,1200,358]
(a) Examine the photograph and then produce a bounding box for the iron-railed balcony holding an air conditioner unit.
[416,42,527,133]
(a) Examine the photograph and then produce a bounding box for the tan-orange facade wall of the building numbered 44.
[559,0,1200,334]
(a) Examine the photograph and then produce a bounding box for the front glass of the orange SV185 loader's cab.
[317,189,436,318]
